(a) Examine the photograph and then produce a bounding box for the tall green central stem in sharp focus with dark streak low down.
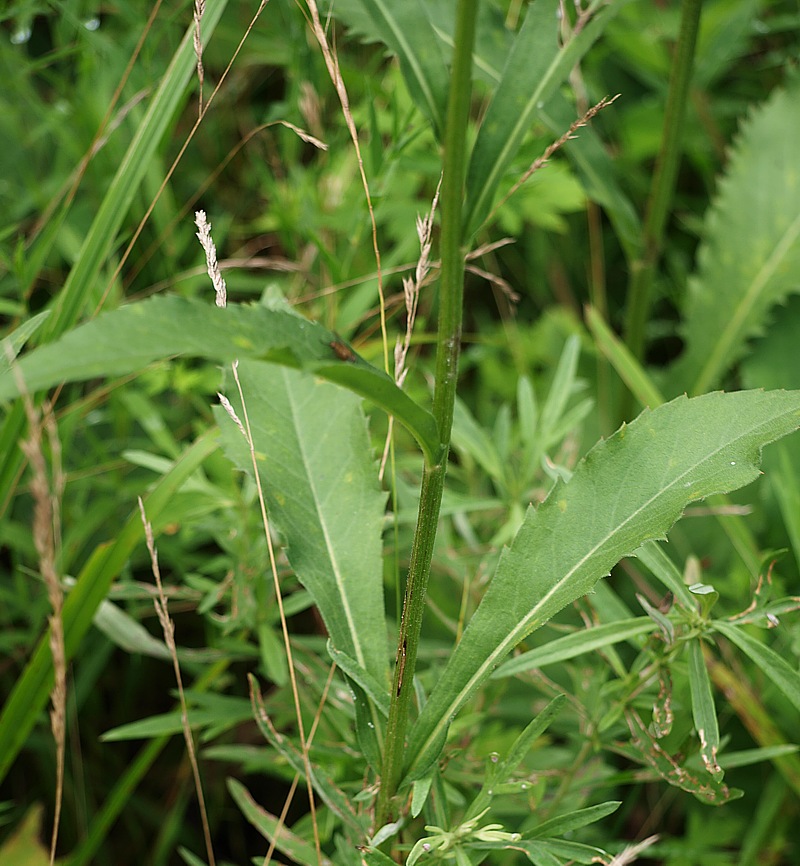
[376,0,478,827]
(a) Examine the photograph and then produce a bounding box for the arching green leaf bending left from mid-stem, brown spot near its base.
[0,296,439,459]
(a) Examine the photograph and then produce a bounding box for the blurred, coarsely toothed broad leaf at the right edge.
[668,83,800,394]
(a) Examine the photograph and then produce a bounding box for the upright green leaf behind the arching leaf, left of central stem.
[216,361,389,763]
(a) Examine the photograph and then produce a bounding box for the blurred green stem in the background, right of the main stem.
[625,0,702,360]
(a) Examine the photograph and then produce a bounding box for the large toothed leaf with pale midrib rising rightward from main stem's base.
[408,391,800,778]
